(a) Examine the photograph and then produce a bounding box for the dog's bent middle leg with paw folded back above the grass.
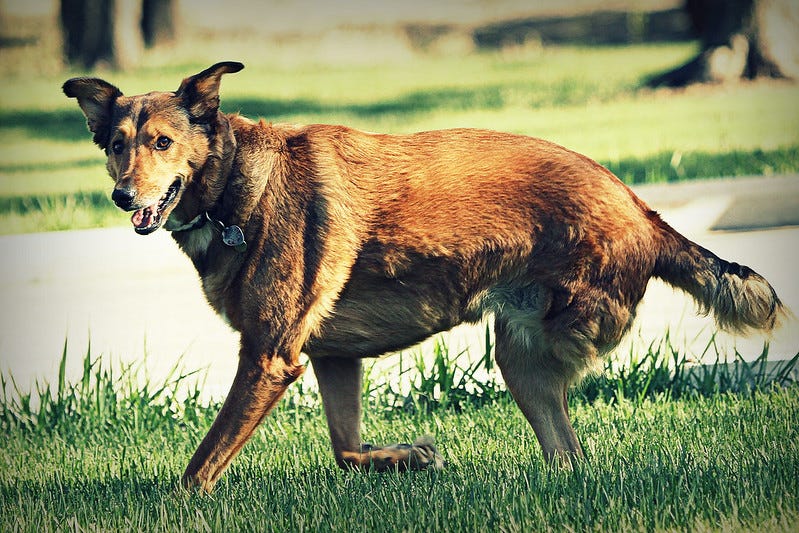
[311,357,444,471]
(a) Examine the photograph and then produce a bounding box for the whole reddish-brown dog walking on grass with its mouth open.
[64,62,783,490]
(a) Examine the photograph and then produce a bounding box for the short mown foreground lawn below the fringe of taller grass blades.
[0,372,799,532]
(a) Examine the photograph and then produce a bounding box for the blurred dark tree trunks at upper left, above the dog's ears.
[60,0,176,70]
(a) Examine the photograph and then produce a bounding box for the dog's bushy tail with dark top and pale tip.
[654,220,789,333]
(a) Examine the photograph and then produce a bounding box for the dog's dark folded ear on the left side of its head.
[62,78,122,149]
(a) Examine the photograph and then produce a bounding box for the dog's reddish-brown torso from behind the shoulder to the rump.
[290,126,657,358]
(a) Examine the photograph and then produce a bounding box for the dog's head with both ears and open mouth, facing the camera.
[63,62,244,235]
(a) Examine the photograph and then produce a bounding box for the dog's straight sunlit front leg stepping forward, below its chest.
[183,349,305,492]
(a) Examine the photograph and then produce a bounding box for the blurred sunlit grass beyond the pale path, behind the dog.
[0,44,799,233]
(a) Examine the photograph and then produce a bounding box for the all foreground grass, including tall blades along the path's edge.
[0,337,799,532]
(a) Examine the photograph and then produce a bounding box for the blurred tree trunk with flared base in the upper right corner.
[649,0,799,87]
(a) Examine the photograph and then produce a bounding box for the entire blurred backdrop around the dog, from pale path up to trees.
[0,0,799,394]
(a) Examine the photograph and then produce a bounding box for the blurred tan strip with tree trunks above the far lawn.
[0,0,799,78]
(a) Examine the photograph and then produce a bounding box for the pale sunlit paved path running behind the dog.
[0,176,799,397]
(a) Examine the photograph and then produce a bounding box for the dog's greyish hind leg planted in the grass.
[494,317,582,465]
